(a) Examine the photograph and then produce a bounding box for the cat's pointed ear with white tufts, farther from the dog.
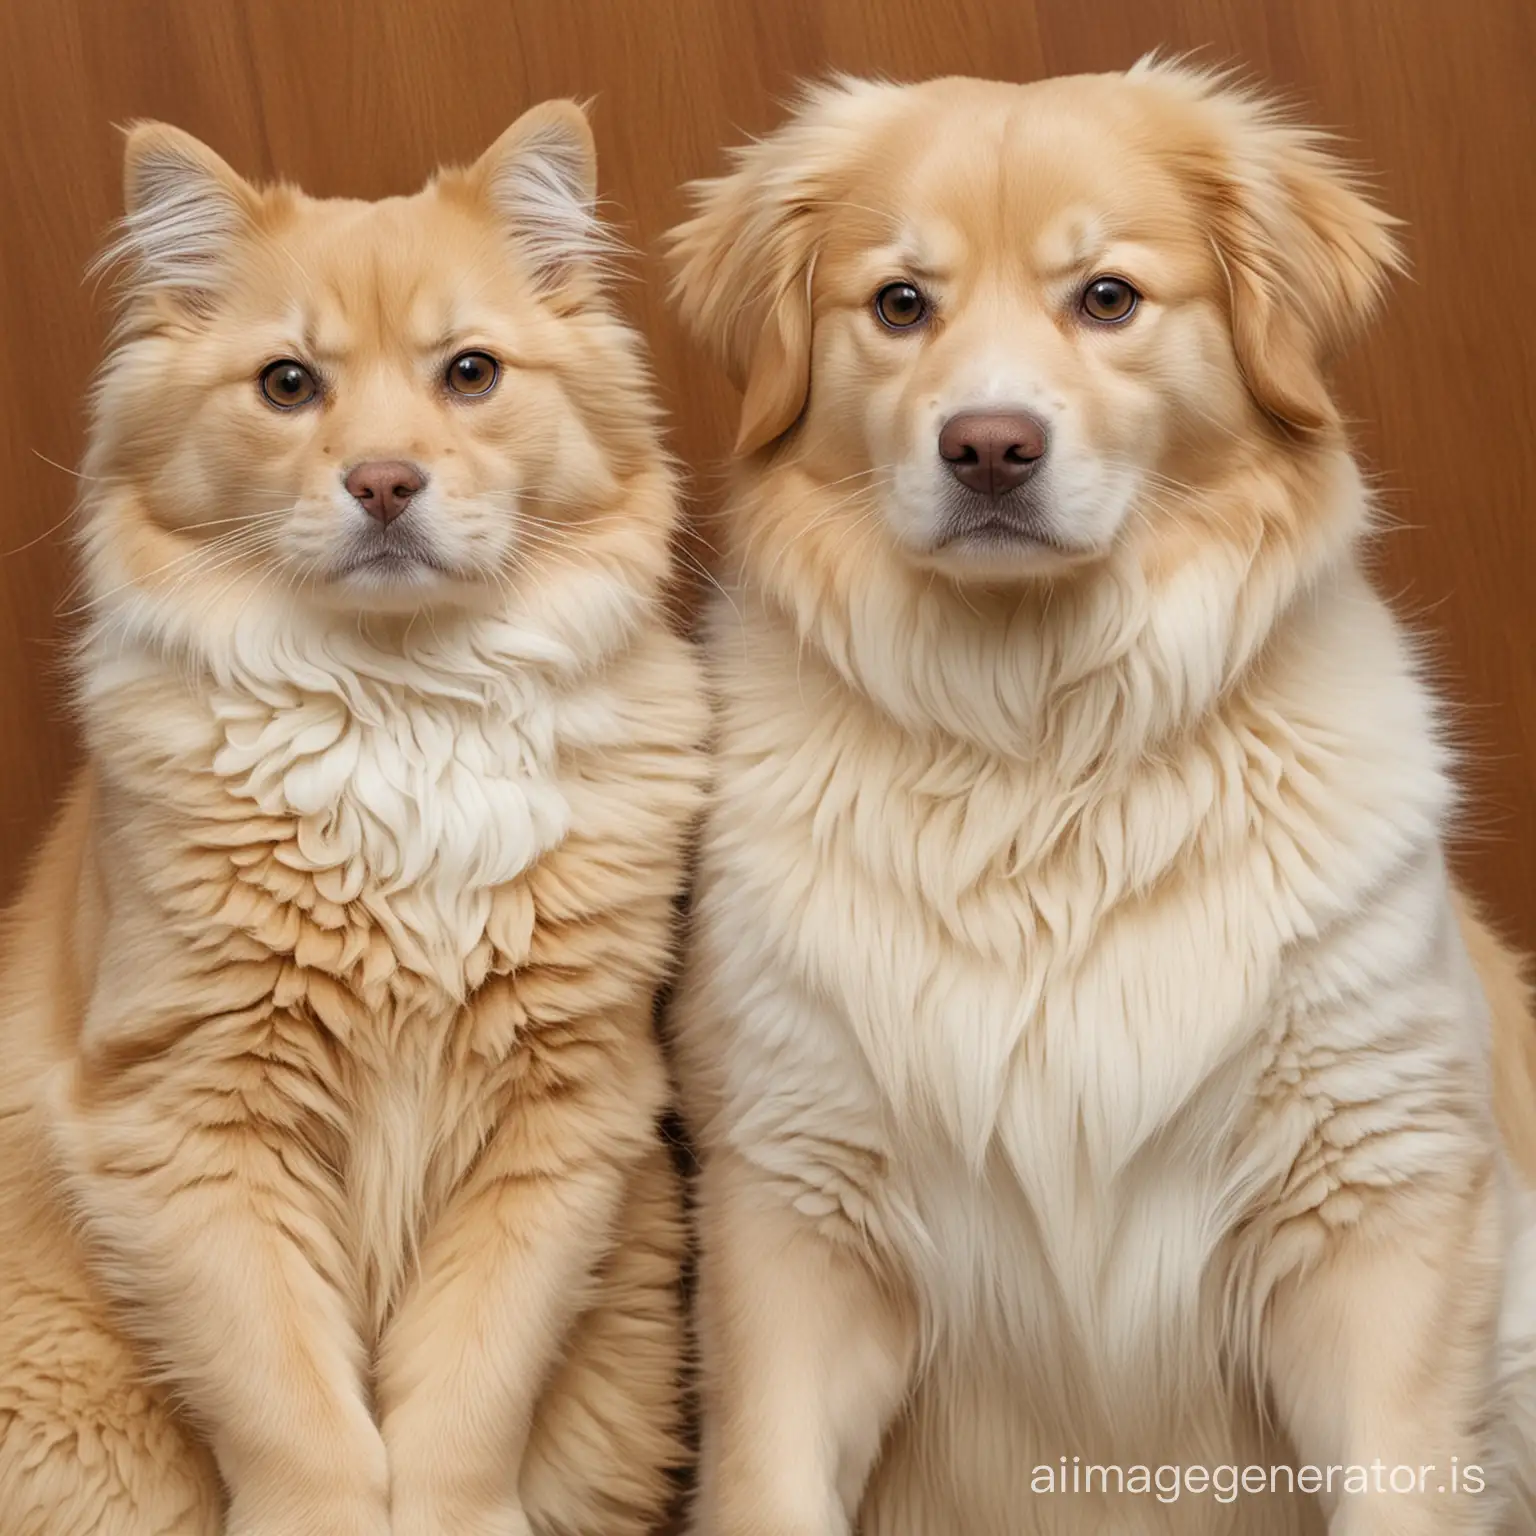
[97,123,258,307]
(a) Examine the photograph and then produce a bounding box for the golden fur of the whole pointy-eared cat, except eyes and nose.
[0,103,705,1536]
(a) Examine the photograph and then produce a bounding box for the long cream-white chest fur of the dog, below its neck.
[699,577,1479,1533]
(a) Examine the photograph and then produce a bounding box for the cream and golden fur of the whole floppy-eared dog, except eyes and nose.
[674,63,1536,1536]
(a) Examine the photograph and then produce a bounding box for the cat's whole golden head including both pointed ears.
[88,103,654,613]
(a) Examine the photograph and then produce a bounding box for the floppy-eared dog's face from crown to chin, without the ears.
[808,77,1235,573]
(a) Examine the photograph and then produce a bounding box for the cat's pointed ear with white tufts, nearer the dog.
[470,101,622,292]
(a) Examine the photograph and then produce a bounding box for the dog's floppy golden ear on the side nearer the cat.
[668,78,885,455]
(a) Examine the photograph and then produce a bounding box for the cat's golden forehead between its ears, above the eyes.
[250,190,521,355]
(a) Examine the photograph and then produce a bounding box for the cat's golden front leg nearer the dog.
[378,983,662,1536]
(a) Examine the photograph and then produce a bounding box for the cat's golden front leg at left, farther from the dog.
[52,1006,390,1536]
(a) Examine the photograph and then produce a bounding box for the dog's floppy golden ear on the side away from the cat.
[1134,63,1405,433]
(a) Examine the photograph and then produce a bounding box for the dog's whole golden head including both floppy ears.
[674,68,1395,581]
